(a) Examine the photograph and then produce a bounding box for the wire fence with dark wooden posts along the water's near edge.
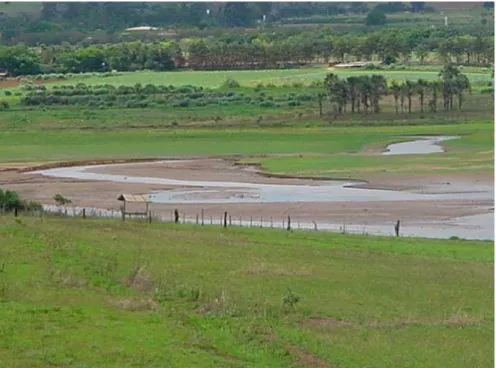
[1,205,400,236]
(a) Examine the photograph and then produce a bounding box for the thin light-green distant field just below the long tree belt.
[52,68,491,88]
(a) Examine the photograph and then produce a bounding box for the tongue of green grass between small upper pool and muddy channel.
[242,121,494,179]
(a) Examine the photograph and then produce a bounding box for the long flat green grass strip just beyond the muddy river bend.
[0,121,494,165]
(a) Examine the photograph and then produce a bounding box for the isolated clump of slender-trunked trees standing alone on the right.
[324,65,470,114]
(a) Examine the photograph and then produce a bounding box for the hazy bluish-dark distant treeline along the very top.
[0,2,429,36]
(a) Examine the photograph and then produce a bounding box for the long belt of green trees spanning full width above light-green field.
[0,29,494,75]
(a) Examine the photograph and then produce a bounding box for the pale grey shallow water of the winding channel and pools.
[31,136,494,239]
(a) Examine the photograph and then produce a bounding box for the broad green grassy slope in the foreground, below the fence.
[0,216,493,368]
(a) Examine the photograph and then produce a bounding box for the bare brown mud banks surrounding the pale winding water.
[0,158,494,228]
